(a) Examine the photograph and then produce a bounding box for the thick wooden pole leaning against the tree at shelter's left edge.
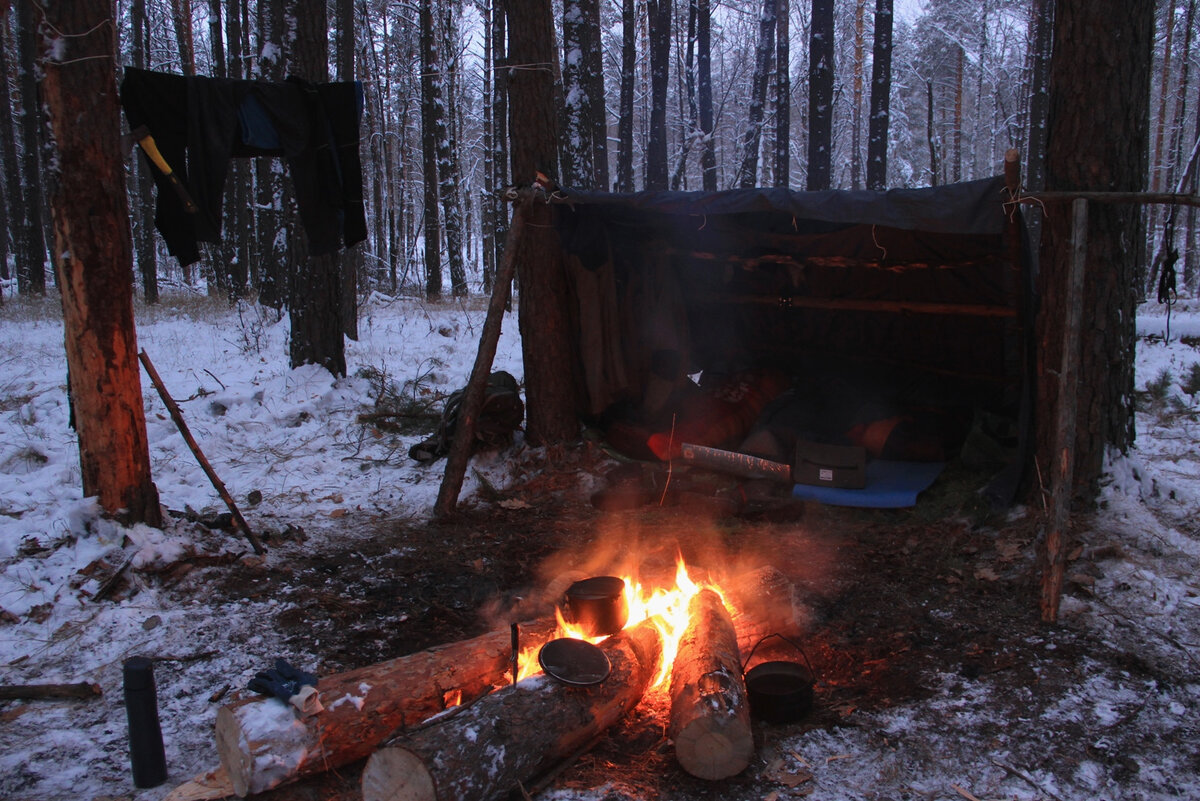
[433,194,532,519]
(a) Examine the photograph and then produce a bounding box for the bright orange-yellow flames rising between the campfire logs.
[517,556,725,687]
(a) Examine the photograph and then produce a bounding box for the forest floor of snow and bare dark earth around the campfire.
[0,288,1200,801]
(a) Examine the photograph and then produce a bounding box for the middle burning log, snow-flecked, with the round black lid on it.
[362,621,662,801]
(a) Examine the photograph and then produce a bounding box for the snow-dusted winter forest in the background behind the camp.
[0,0,1200,308]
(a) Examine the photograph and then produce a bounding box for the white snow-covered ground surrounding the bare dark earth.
[0,288,1200,801]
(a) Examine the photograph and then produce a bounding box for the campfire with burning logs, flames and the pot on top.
[217,558,811,801]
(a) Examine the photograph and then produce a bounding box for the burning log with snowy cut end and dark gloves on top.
[216,620,556,797]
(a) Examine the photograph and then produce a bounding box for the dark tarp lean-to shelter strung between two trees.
[552,177,1032,506]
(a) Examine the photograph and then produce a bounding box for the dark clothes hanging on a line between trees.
[121,67,367,265]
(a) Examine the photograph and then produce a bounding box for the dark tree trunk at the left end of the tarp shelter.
[505,0,580,445]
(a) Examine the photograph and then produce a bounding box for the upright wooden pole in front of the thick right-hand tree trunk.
[1040,198,1087,622]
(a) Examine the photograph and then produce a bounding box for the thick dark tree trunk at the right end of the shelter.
[1036,0,1154,499]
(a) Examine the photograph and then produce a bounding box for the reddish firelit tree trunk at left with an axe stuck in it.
[36,0,162,526]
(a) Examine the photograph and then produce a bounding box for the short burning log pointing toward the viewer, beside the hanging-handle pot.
[668,590,754,779]
